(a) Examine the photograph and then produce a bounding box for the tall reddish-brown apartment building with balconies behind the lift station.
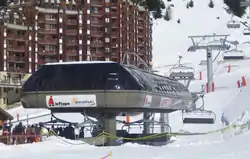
[0,0,152,106]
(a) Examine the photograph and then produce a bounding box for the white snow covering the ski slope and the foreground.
[3,0,250,159]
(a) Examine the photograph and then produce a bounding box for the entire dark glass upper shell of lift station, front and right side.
[23,63,188,95]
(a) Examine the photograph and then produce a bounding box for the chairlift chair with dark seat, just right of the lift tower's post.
[223,49,245,60]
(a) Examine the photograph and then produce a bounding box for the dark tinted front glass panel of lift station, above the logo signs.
[23,63,140,91]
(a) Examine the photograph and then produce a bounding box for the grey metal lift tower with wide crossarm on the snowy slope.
[188,34,230,92]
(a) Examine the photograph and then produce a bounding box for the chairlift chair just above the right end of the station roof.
[169,65,195,80]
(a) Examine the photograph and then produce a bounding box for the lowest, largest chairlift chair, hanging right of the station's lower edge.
[182,110,216,124]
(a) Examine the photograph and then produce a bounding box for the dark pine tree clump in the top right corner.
[224,0,247,17]
